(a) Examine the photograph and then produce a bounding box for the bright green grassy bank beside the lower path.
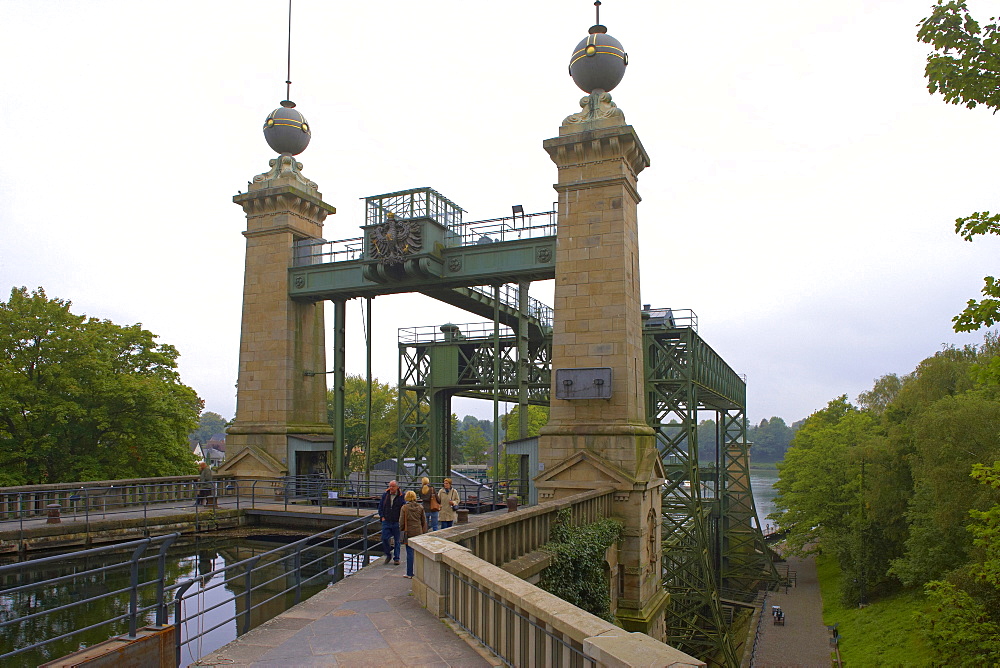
[816,555,934,668]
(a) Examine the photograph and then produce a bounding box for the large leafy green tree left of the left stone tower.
[0,288,201,485]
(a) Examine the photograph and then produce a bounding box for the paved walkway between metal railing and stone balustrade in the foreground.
[191,559,502,668]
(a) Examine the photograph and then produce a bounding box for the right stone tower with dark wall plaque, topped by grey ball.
[535,18,668,640]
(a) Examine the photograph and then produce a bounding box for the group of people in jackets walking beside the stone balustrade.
[378,478,461,578]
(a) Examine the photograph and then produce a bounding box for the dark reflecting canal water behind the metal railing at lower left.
[0,535,363,666]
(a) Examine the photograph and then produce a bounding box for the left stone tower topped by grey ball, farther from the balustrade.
[220,100,336,476]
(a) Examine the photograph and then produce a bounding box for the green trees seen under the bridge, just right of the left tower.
[326,375,398,471]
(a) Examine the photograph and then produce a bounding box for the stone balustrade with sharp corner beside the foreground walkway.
[410,487,705,668]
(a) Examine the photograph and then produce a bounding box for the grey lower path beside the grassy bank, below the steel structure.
[754,557,832,668]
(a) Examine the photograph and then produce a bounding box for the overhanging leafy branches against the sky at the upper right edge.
[917,0,1000,332]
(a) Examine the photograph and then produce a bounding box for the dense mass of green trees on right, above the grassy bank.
[774,337,1000,604]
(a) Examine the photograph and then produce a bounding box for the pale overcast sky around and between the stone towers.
[0,0,1000,423]
